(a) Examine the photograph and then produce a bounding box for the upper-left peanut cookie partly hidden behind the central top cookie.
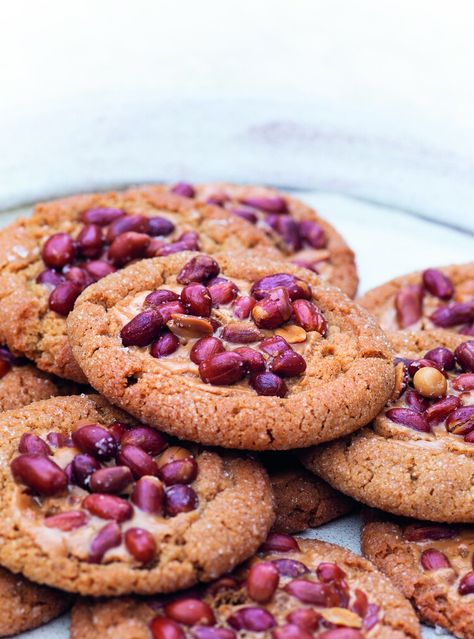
[0,189,280,383]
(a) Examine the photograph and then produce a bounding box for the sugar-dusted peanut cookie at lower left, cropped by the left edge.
[0,396,274,595]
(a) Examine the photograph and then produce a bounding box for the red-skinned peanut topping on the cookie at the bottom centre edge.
[150,534,379,639]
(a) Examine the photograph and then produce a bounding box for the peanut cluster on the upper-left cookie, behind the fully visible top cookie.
[36,208,199,316]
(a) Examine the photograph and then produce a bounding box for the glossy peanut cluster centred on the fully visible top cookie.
[120,255,327,397]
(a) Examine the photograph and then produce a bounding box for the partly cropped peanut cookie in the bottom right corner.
[362,513,474,639]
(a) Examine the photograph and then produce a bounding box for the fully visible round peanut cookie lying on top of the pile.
[68,253,394,450]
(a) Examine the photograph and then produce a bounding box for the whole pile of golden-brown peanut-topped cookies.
[0,183,468,639]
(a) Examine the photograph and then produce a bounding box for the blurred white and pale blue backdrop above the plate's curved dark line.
[0,0,474,232]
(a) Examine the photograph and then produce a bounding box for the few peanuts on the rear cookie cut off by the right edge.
[395,268,474,335]
